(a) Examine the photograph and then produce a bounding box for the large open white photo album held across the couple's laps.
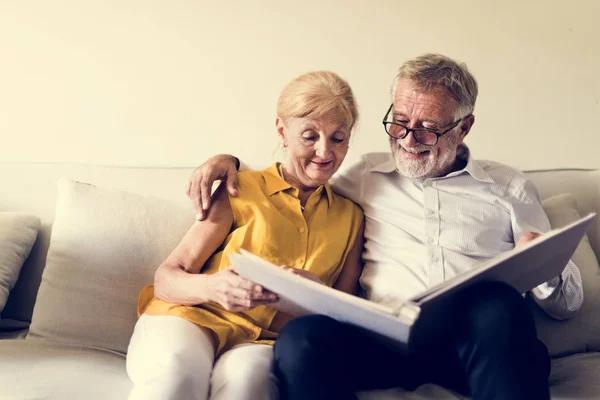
[229,213,596,350]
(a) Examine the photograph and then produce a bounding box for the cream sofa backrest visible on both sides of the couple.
[0,163,600,328]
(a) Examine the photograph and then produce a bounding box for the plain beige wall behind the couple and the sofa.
[0,0,600,169]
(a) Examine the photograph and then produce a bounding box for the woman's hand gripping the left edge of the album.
[206,267,279,312]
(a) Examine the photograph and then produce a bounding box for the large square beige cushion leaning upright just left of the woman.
[28,179,194,353]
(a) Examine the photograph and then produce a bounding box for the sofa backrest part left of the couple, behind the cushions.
[0,163,194,322]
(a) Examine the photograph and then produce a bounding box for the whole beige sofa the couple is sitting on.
[0,163,600,400]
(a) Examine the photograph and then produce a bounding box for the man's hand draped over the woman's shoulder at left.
[185,154,238,221]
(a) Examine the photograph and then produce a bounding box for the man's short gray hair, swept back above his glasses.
[391,53,478,118]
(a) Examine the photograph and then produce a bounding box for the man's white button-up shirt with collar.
[332,145,583,319]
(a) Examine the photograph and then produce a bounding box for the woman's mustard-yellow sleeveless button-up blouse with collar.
[138,164,363,354]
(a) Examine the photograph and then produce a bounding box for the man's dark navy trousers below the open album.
[274,283,550,400]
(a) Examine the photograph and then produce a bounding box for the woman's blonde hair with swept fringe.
[277,71,358,129]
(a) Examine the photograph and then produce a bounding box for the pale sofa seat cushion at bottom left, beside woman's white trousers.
[0,339,132,400]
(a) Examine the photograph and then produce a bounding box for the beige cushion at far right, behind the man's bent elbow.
[532,193,600,357]
